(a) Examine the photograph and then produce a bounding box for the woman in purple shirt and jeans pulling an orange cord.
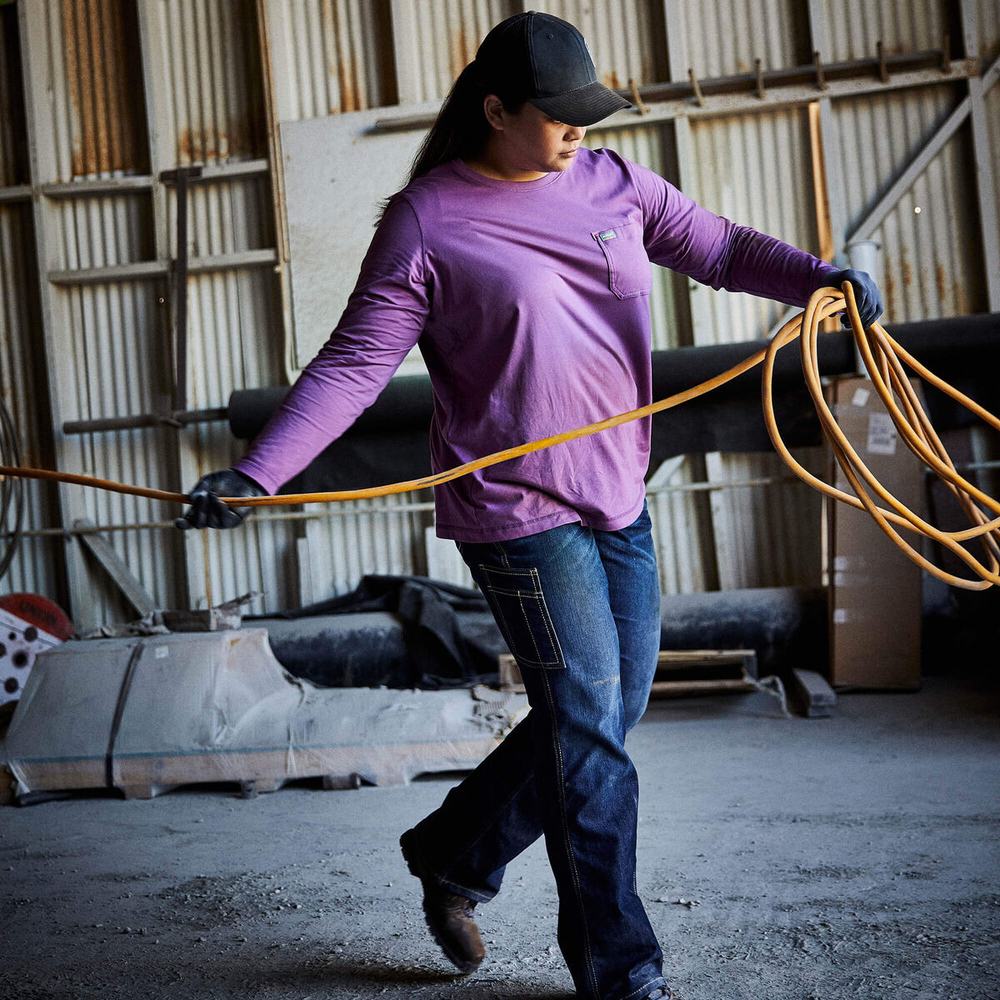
[179,12,881,1000]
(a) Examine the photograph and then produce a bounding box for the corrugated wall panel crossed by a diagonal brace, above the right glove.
[827,86,980,323]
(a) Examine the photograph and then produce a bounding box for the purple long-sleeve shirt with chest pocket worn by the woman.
[235,147,836,542]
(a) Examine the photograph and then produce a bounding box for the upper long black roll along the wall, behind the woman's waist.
[229,313,1000,493]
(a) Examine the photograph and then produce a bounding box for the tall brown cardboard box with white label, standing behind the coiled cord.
[825,377,924,690]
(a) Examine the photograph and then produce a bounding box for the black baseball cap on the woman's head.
[474,10,632,125]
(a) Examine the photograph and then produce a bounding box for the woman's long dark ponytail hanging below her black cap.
[375,62,527,226]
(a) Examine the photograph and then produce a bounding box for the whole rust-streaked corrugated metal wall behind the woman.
[0,0,1000,624]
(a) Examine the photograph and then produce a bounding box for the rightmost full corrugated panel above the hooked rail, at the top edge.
[823,0,949,62]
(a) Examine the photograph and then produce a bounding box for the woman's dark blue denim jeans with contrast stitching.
[416,505,665,1000]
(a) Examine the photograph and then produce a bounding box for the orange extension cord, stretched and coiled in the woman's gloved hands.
[0,282,1000,590]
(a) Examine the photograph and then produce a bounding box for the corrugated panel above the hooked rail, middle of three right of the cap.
[666,0,808,80]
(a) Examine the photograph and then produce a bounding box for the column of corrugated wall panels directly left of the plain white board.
[140,0,298,612]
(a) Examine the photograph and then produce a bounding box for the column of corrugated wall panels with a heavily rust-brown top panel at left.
[18,0,177,627]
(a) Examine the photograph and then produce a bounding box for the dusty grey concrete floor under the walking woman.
[0,678,1000,1000]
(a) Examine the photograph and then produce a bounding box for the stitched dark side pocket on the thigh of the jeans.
[479,563,566,670]
